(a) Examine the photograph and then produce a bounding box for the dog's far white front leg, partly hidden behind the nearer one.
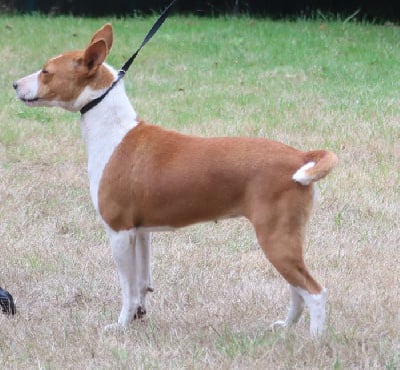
[136,231,153,318]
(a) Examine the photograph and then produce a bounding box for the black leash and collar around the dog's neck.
[80,0,178,114]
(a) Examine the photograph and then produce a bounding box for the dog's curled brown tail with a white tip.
[292,150,338,186]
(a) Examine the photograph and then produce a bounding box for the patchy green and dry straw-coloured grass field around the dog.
[0,16,400,369]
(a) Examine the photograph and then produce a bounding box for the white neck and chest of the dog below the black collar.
[81,67,137,211]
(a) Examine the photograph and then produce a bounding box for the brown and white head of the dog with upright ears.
[13,24,115,112]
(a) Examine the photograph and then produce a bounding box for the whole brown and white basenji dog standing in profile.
[14,24,337,336]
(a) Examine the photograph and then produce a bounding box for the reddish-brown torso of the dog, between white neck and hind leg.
[98,122,304,230]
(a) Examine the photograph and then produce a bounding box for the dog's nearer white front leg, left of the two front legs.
[108,230,140,326]
